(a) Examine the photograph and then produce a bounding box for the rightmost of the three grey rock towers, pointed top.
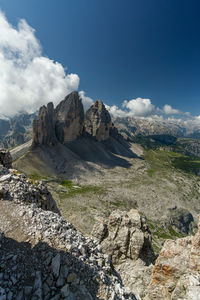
[84,100,112,142]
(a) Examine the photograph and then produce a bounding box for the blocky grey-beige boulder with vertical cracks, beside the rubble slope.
[92,209,154,264]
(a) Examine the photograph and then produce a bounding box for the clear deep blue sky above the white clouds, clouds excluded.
[0,0,200,115]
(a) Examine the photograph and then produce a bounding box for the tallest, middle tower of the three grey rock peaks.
[55,92,84,144]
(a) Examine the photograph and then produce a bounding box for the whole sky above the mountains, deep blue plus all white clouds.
[0,0,200,127]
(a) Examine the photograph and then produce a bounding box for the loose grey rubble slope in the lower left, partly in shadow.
[0,154,136,300]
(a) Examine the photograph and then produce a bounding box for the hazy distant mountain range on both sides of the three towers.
[0,101,200,148]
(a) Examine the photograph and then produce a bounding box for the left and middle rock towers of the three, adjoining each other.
[33,92,84,146]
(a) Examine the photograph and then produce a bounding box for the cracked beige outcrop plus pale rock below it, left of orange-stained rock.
[92,209,155,297]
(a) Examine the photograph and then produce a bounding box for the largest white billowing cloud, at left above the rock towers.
[0,11,79,115]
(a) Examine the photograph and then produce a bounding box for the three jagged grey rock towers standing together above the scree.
[33,92,117,146]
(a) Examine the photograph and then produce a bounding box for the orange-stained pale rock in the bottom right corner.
[145,218,200,300]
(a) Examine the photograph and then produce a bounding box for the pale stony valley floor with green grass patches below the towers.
[14,144,200,251]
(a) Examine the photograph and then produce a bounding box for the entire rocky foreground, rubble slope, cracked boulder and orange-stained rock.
[0,152,200,300]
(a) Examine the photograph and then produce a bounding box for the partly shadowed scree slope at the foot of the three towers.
[14,138,138,179]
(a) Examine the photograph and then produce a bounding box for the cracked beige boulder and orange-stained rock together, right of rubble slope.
[93,210,200,300]
